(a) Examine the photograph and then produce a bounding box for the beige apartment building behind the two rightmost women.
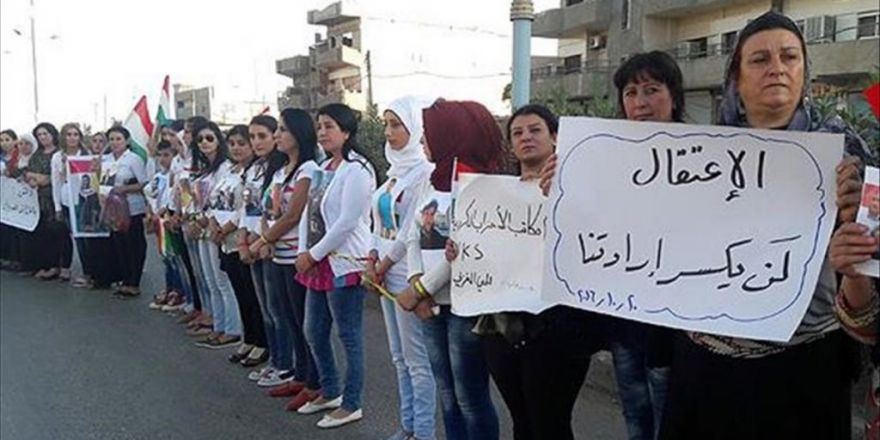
[532,0,880,123]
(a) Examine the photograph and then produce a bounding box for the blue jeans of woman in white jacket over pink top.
[305,286,364,411]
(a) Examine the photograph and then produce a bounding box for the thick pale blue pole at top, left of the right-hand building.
[510,0,535,110]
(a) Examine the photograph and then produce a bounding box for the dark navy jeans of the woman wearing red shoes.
[268,263,320,390]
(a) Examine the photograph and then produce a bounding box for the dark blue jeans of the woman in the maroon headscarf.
[425,306,498,440]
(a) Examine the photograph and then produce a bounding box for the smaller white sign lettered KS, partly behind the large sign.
[450,174,547,316]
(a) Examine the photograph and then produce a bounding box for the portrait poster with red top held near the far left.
[67,156,110,237]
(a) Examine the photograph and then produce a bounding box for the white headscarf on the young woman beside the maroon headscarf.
[385,96,434,178]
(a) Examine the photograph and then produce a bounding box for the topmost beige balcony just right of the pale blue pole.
[532,0,611,38]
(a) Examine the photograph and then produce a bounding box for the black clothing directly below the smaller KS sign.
[482,306,598,440]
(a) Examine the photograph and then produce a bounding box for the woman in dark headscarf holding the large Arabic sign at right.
[660,12,878,439]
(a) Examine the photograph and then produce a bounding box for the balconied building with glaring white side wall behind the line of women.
[276,0,511,113]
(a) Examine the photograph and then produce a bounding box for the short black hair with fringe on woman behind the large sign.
[614,50,685,122]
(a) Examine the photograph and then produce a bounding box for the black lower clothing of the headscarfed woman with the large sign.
[660,330,852,440]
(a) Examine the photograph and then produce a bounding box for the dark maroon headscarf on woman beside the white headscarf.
[423,101,504,192]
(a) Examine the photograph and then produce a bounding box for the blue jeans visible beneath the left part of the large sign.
[611,341,669,440]
